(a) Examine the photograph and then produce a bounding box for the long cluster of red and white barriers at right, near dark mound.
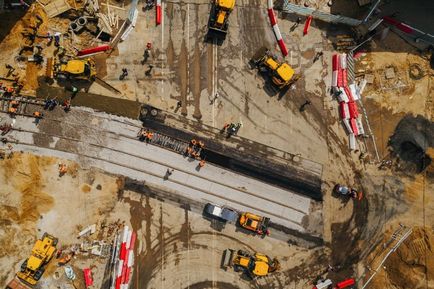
[332,53,364,150]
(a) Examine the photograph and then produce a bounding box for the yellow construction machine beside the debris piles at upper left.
[45,58,96,81]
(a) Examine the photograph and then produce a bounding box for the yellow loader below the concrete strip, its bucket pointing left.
[222,249,280,278]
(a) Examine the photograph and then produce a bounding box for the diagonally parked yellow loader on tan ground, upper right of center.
[251,47,300,89]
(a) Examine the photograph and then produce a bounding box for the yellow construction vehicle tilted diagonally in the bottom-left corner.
[17,233,57,285]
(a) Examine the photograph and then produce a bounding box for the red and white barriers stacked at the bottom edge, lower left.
[110,226,136,289]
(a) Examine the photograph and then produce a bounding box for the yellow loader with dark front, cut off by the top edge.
[208,0,235,41]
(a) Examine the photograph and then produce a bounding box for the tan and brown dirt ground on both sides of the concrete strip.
[0,1,434,289]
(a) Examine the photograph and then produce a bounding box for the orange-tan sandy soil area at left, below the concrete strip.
[0,153,118,286]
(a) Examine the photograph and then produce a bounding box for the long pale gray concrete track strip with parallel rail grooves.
[2,109,322,235]
